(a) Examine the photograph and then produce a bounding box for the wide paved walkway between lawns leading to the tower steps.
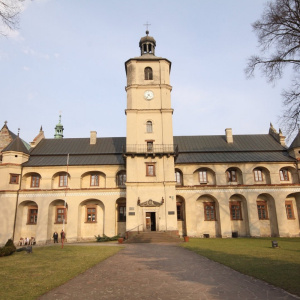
[40,244,300,300]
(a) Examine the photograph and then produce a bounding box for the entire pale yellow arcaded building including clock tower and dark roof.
[0,34,300,244]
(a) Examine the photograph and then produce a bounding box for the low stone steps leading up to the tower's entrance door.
[125,231,183,243]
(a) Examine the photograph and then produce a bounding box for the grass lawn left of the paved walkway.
[0,245,122,299]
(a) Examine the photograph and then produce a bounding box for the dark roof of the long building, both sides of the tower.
[24,134,294,166]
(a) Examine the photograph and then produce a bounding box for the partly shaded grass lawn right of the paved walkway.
[183,238,300,296]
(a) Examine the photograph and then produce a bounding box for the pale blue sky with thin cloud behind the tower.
[0,0,290,142]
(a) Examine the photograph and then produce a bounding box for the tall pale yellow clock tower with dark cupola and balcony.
[125,31,177,232]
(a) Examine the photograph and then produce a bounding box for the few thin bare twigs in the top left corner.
[0,0,24,35]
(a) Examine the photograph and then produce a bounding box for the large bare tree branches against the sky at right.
[245,0,300,137]
